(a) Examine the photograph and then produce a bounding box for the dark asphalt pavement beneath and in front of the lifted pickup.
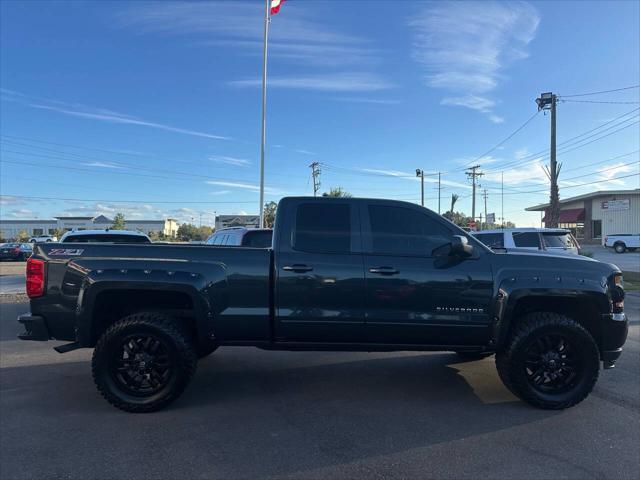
[0,294,640,479]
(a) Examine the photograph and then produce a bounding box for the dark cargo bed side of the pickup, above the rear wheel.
[31,243,273,345]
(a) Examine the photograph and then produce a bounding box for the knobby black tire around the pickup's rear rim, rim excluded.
[91,312,198,413]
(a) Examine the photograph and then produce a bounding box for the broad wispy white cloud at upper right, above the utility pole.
[409,1,540,123]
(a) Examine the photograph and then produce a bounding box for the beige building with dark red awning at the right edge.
[526,189,640,243]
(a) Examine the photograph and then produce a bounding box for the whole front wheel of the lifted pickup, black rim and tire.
[496,312,600,410]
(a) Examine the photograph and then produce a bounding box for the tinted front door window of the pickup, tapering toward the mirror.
[369,205,452,256]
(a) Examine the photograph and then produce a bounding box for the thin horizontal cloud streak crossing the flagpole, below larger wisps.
[228,72,395,92]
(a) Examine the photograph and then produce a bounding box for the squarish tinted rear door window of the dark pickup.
[294,203,351,253]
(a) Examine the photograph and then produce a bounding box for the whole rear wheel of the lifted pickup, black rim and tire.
[92,313,197,413]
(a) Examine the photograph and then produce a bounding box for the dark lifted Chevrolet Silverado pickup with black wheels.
[18,197,628,412]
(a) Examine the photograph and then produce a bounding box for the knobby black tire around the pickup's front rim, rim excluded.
[496,312,600,410]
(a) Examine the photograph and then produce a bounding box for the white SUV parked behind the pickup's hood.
[471,228,580,255]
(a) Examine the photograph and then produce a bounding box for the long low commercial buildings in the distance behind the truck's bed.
[0,215,178,240]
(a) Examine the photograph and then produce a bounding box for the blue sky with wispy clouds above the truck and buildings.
[0,0,640,226]
